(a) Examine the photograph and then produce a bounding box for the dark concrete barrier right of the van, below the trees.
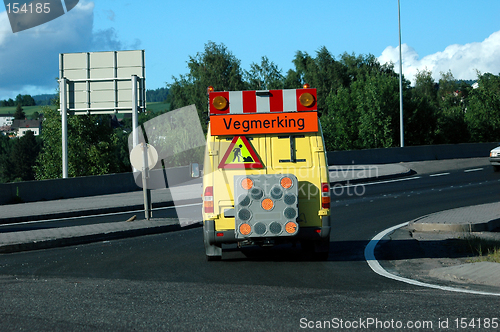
[328,143,499,165]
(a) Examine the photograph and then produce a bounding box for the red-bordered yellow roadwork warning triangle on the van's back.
[219,136,264,168]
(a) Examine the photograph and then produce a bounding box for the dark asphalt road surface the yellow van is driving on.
[0,162,500,331]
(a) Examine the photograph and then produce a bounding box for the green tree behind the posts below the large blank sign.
[35,108,120,180]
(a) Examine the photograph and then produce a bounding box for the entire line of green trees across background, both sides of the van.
[0,42,500,182]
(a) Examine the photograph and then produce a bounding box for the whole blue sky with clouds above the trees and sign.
[0,0,500,99]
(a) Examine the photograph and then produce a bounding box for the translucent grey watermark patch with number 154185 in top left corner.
[4,0,79,33]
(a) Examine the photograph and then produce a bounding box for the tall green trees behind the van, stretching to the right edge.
[168,42,500,151]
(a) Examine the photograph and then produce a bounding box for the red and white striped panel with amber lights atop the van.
[209,88,317,116]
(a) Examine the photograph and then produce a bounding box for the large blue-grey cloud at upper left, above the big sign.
[0,1,137,99]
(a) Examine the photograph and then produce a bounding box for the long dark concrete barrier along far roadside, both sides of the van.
[0,143,498,204]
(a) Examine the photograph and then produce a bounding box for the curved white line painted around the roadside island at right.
[365,222,500,296]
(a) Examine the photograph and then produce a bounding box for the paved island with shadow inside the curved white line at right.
[375,226,500,293]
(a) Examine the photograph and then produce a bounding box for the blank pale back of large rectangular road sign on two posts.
[59,50,146,114]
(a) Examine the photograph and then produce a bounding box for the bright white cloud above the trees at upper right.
[378,31,500,82]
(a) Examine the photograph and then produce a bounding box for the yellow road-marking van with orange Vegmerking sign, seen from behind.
[203,85,330,260]
